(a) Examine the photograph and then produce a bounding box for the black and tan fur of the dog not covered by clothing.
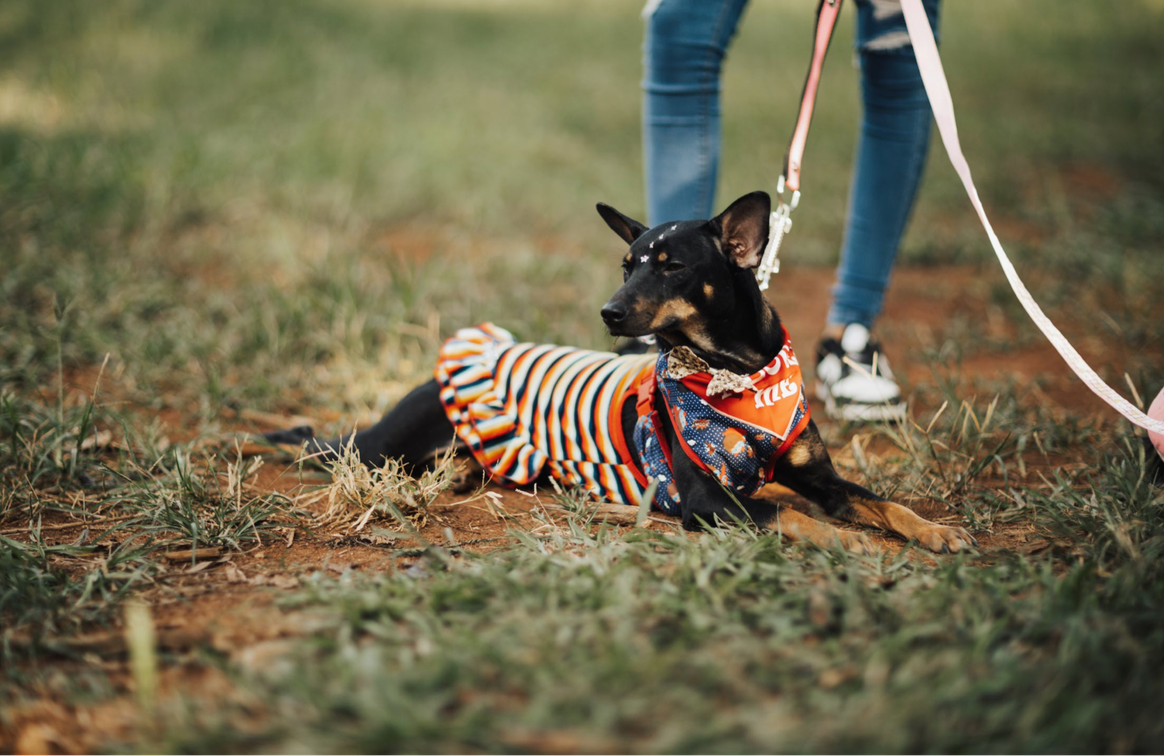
[268,192,977,552]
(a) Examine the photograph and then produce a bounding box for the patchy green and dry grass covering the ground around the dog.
[0,0,1164,754]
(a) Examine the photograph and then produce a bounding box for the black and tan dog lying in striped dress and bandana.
[265,192,978,553]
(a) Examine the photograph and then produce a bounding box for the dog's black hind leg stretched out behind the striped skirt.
[263,381,456,468]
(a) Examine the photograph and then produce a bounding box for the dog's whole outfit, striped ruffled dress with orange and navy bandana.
[433,323,808,514]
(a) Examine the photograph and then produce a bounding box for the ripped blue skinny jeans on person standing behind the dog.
[643,0,939,326]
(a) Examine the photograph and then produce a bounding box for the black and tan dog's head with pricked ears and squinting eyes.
[598,192,772,344]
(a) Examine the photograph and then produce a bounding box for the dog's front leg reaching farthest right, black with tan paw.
[775,422,978,553]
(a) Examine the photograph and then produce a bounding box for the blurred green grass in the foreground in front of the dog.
[152,454,1164,754]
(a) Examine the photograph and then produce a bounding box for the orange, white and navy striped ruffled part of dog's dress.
[433,323,654,504]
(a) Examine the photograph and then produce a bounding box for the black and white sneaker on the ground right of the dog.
[816,323,906,423]
